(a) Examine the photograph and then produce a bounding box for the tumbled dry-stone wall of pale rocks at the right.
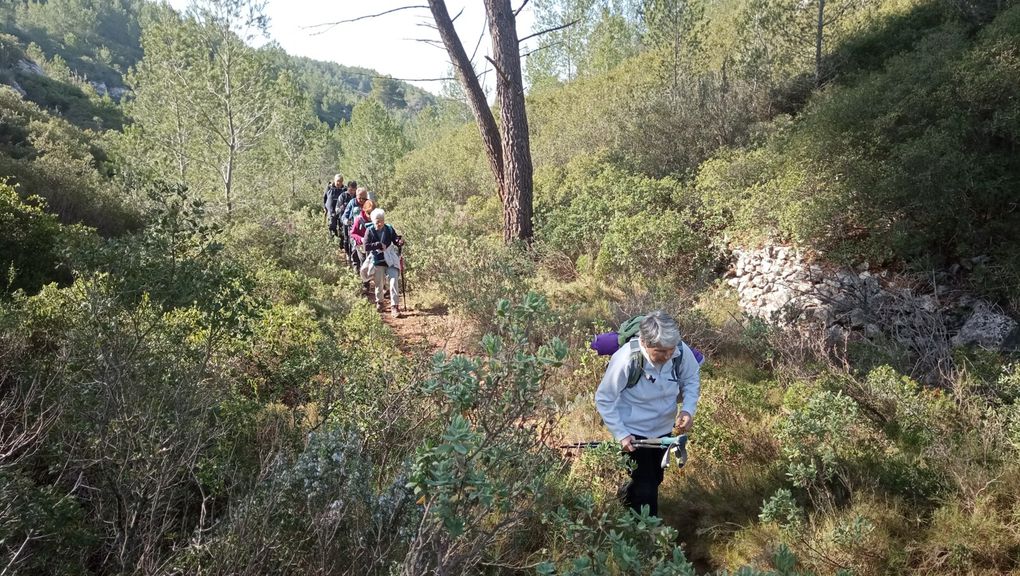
[726,246,1020,352]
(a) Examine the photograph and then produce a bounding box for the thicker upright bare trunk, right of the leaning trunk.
[486,0,532,243]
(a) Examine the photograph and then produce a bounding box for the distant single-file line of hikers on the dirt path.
[322,174,404,318]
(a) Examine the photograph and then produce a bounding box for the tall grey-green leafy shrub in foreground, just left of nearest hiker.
[407,294,567,573]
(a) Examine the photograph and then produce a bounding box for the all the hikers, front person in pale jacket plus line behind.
[322,174,704,516]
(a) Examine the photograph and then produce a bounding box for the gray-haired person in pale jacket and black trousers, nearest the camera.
[595,310,701,516]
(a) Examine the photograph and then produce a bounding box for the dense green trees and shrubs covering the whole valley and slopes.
[0,0,1020,575]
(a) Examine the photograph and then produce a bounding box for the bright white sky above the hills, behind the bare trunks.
[168,0,534,93]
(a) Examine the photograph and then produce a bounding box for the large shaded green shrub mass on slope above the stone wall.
[698,7,1020,296]
